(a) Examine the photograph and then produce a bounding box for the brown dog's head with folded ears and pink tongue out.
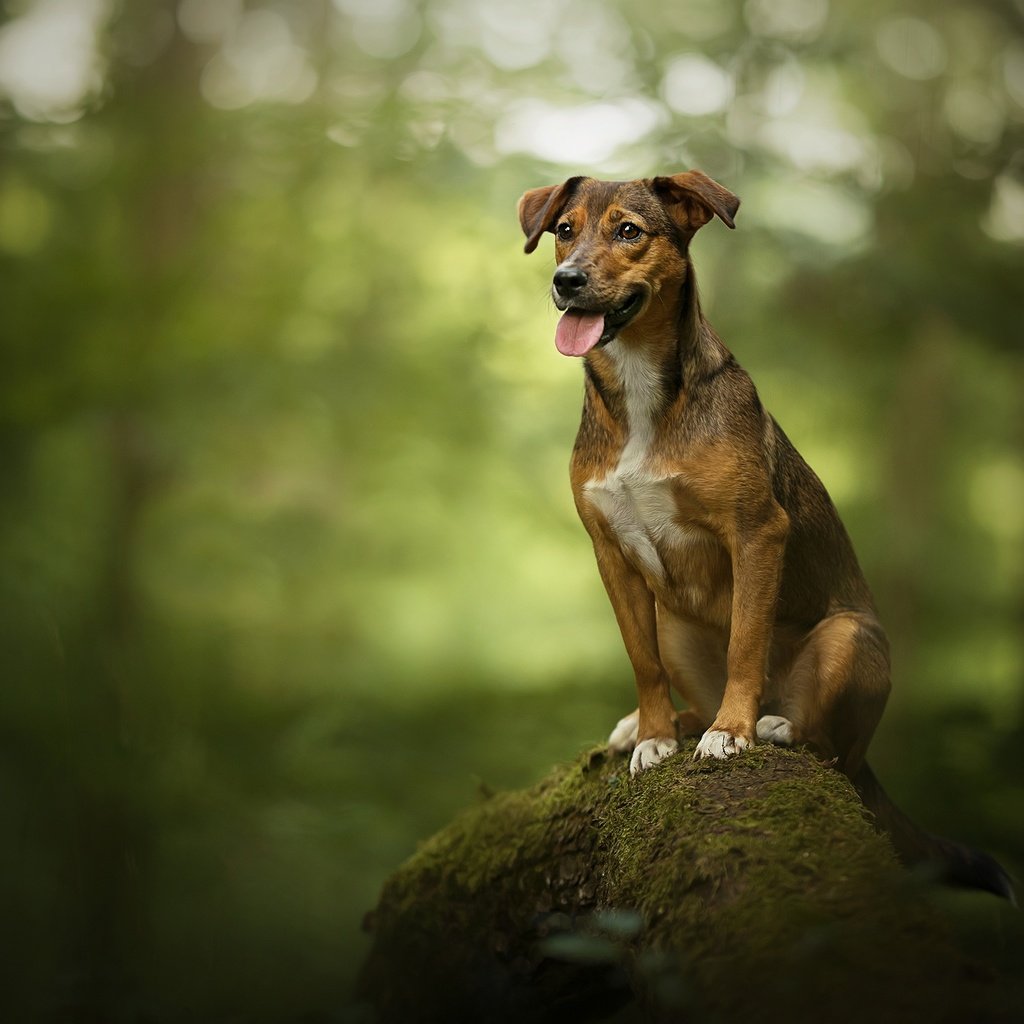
[519,171,739,355]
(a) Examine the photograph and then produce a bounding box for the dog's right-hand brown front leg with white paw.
[694,503,790,759]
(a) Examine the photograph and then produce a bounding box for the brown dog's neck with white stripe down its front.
[586,263,731,431]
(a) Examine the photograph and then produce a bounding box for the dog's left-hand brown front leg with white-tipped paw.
[594,535,679,775]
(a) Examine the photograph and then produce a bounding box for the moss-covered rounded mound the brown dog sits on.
[358,744,985,1024]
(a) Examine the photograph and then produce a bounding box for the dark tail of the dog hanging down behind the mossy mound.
[853,762,1017,906]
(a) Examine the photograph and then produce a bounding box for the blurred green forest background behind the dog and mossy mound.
[0,0,1024,1022]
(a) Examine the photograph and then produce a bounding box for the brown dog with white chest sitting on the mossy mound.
[518,170,1014,900]
